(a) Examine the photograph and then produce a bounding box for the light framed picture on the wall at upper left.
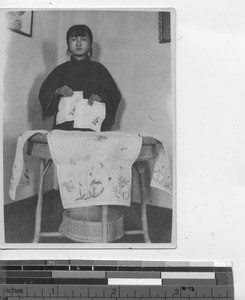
[7,11,33,37]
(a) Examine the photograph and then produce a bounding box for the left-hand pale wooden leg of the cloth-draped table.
[33,158,52,243]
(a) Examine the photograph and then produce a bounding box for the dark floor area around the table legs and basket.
[4,191,172,243]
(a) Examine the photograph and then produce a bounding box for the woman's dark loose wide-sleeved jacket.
[39,58,121,131]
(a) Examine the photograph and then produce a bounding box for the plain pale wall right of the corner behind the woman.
[59,10,175,207]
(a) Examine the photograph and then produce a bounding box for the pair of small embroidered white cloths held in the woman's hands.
[56,91,106,131]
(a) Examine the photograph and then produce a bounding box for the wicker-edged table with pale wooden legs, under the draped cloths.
[27,133,159,243]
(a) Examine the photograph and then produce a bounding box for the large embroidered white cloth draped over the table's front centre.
[47,130,142,209]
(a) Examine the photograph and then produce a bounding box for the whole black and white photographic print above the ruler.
[1,8,176,248]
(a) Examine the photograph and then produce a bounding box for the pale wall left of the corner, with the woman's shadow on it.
[3,11,59,203]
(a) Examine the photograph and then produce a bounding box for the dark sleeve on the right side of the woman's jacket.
[99,66,121,129]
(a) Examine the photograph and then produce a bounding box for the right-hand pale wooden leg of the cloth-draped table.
[136,161,151,243]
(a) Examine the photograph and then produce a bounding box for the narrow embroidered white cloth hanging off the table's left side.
[9,130,47,200]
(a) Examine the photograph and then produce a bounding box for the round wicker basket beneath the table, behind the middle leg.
[60,206,124,243]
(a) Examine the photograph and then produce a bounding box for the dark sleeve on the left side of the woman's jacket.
[39,68,61,120]
